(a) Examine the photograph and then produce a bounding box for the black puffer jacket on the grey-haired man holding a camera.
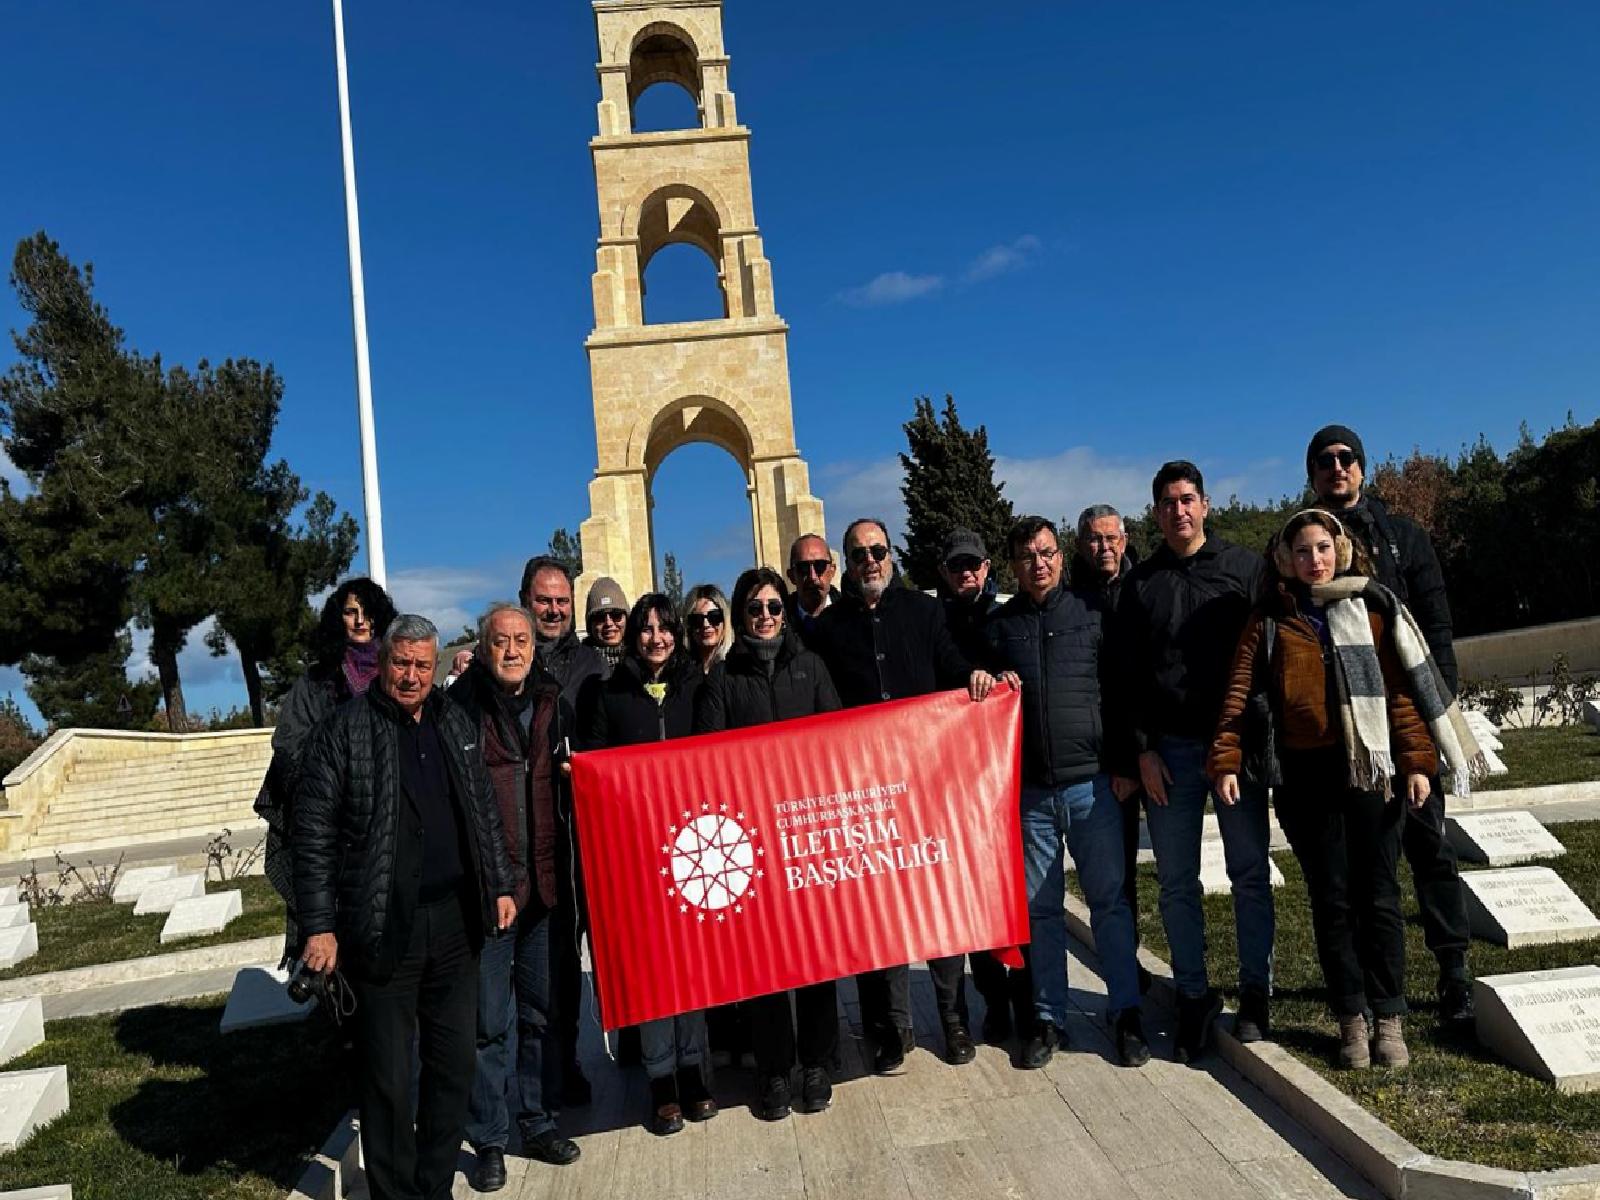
[294,685,517,982]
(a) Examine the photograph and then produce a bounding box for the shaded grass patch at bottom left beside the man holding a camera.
[0,1000,354,1200]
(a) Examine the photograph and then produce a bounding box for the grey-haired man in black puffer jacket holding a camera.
[294,614,518,1200]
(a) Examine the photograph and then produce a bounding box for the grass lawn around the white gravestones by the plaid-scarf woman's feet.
[1120,825,1600,1170]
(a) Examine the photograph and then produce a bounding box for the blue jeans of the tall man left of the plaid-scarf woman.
[1144,738,1274,998]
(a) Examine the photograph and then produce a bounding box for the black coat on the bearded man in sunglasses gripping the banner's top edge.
[806,581,974,709]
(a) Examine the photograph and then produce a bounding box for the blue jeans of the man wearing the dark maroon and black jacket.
[467,912,562,1150]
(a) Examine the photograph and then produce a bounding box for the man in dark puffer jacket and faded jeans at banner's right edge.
[989,517,1150,1069]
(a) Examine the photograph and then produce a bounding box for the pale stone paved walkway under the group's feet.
[393,944,1378,1200]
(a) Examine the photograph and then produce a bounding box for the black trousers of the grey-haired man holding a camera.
[354,898,478,1200]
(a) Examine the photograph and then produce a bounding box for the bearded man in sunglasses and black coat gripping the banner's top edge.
[811,517,995,1074]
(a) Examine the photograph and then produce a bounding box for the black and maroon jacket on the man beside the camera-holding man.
[445,659,573,912]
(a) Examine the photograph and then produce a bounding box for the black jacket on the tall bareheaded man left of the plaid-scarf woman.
[1112,538,1267,755]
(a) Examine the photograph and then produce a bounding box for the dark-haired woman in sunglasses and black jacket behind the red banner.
[694,566,840,1122]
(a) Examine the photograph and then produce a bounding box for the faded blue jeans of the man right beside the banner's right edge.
[1022,774,1139,1029]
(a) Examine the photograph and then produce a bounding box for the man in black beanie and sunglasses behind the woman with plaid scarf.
[1306,426,1472,1024]
